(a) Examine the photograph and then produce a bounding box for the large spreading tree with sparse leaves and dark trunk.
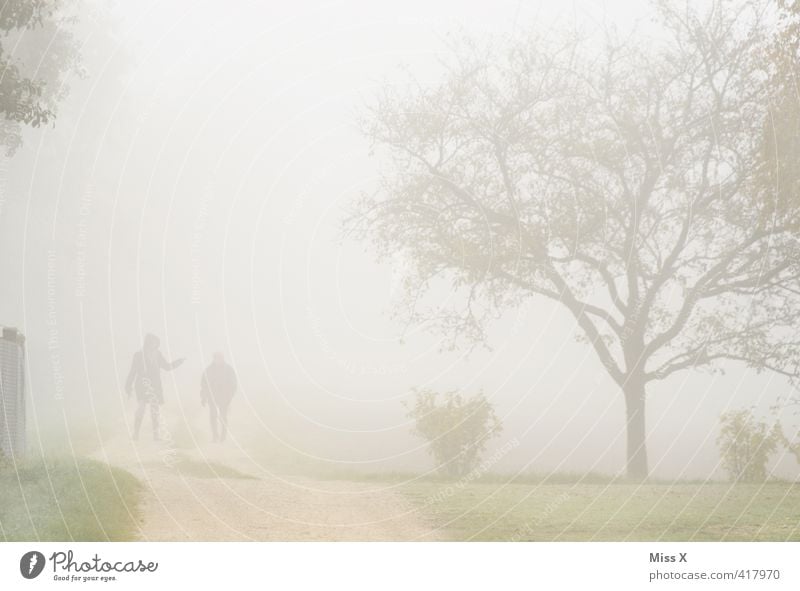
[353,0,800,478]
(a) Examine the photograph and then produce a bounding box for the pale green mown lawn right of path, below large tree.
[400,481,800,541]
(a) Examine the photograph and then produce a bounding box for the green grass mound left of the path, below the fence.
[0,458,142,542]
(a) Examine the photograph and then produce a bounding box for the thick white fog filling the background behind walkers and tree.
[0,0,798,478]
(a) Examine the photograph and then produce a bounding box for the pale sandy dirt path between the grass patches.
[94,438,444,541]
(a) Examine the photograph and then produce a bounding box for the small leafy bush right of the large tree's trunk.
[717,409,784,482]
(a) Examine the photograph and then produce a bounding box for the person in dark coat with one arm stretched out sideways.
[125,334,184,441]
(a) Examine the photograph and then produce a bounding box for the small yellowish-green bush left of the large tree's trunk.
[406,390,502,478]
